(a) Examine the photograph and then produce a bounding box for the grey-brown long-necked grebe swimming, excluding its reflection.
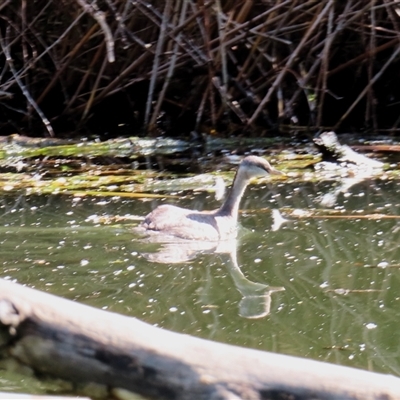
[140,156,281,241]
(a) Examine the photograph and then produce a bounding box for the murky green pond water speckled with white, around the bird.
[0,180,400,391]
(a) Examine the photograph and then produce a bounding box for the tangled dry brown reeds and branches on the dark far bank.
[0,0,400,136]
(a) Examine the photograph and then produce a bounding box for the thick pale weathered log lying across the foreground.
[0,279,400,400]
